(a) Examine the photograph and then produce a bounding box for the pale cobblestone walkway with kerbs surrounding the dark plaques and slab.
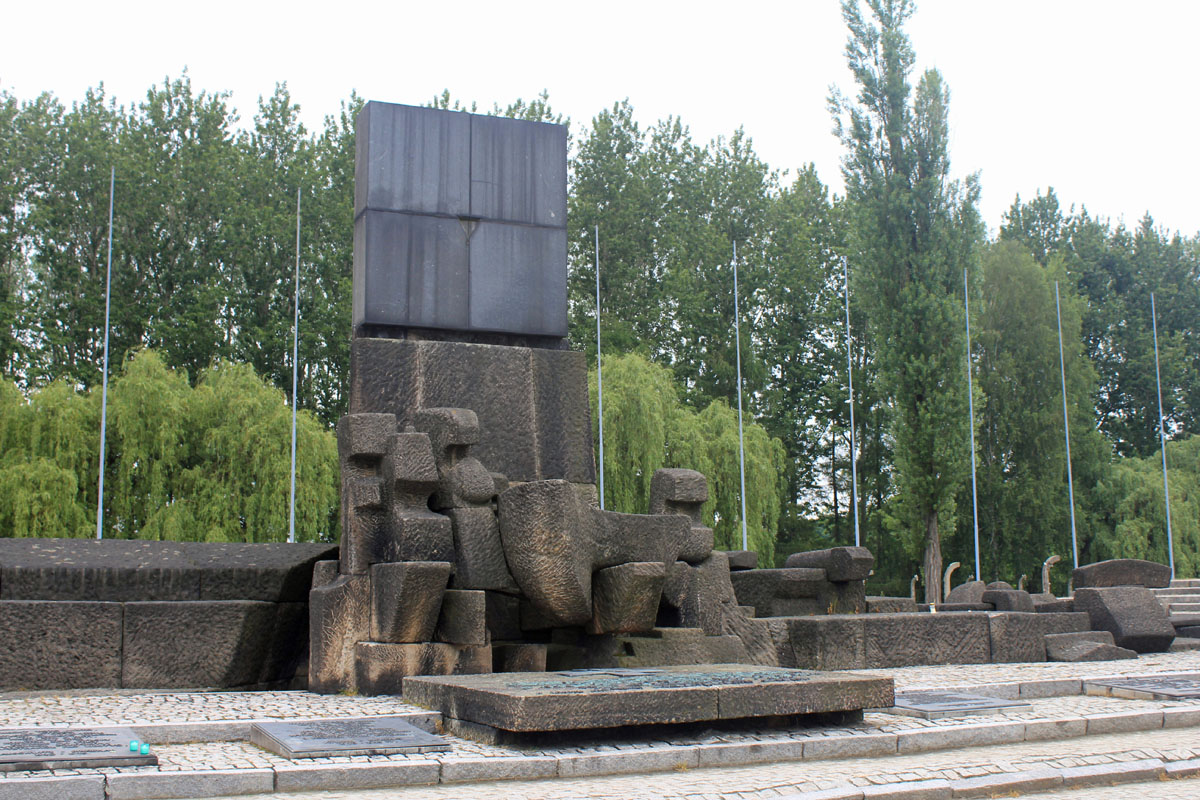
[0,651,1200,800]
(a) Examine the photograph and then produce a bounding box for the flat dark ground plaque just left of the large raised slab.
[250,717,450,758]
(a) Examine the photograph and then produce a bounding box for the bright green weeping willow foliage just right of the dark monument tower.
[589,354,785,564]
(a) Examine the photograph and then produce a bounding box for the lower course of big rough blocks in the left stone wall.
[0,600,308,690]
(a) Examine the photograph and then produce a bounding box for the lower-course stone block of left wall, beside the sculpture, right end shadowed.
[121,601,291,688]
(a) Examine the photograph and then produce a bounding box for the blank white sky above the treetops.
[0,0,1200,235]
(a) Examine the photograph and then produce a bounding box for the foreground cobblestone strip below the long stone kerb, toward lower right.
[201,729,1200,800]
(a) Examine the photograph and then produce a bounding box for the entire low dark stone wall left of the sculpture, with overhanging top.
[0,539,336,690]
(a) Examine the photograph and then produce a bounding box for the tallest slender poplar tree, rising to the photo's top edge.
[830,0,982,602]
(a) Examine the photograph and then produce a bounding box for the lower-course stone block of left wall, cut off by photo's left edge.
[0,600,122,690]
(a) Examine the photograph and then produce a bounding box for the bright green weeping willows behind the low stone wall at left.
[0,350,338,542]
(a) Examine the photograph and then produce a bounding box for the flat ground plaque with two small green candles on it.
[0,728,158,772]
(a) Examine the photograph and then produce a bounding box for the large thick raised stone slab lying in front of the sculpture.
[404,664,893,733]
